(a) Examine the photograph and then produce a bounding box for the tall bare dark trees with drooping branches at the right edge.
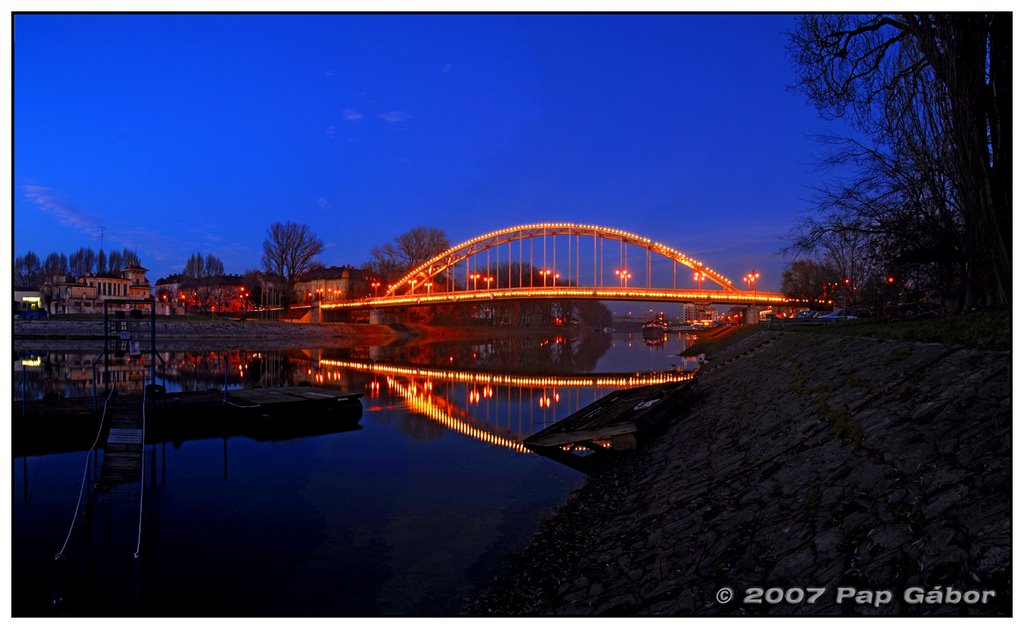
[786,12,1013,311]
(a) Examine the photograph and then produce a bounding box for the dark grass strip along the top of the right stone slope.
[771,310,1012,351]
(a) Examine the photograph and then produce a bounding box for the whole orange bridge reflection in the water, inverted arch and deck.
[319,359,693,454]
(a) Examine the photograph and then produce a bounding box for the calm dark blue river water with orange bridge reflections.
[12,334,686,616]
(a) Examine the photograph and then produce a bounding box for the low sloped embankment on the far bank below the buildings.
[14,319,410,349]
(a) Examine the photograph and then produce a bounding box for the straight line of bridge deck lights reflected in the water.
[319,359,693,387]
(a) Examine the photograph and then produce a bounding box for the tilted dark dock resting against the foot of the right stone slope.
[523,381,694,471]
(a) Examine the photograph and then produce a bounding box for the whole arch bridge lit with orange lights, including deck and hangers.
[321,222,790,309]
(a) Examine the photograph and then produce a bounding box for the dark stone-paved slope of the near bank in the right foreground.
[466,331,1012,616]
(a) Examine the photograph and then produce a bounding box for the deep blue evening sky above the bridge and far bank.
[13,15,847,289]
